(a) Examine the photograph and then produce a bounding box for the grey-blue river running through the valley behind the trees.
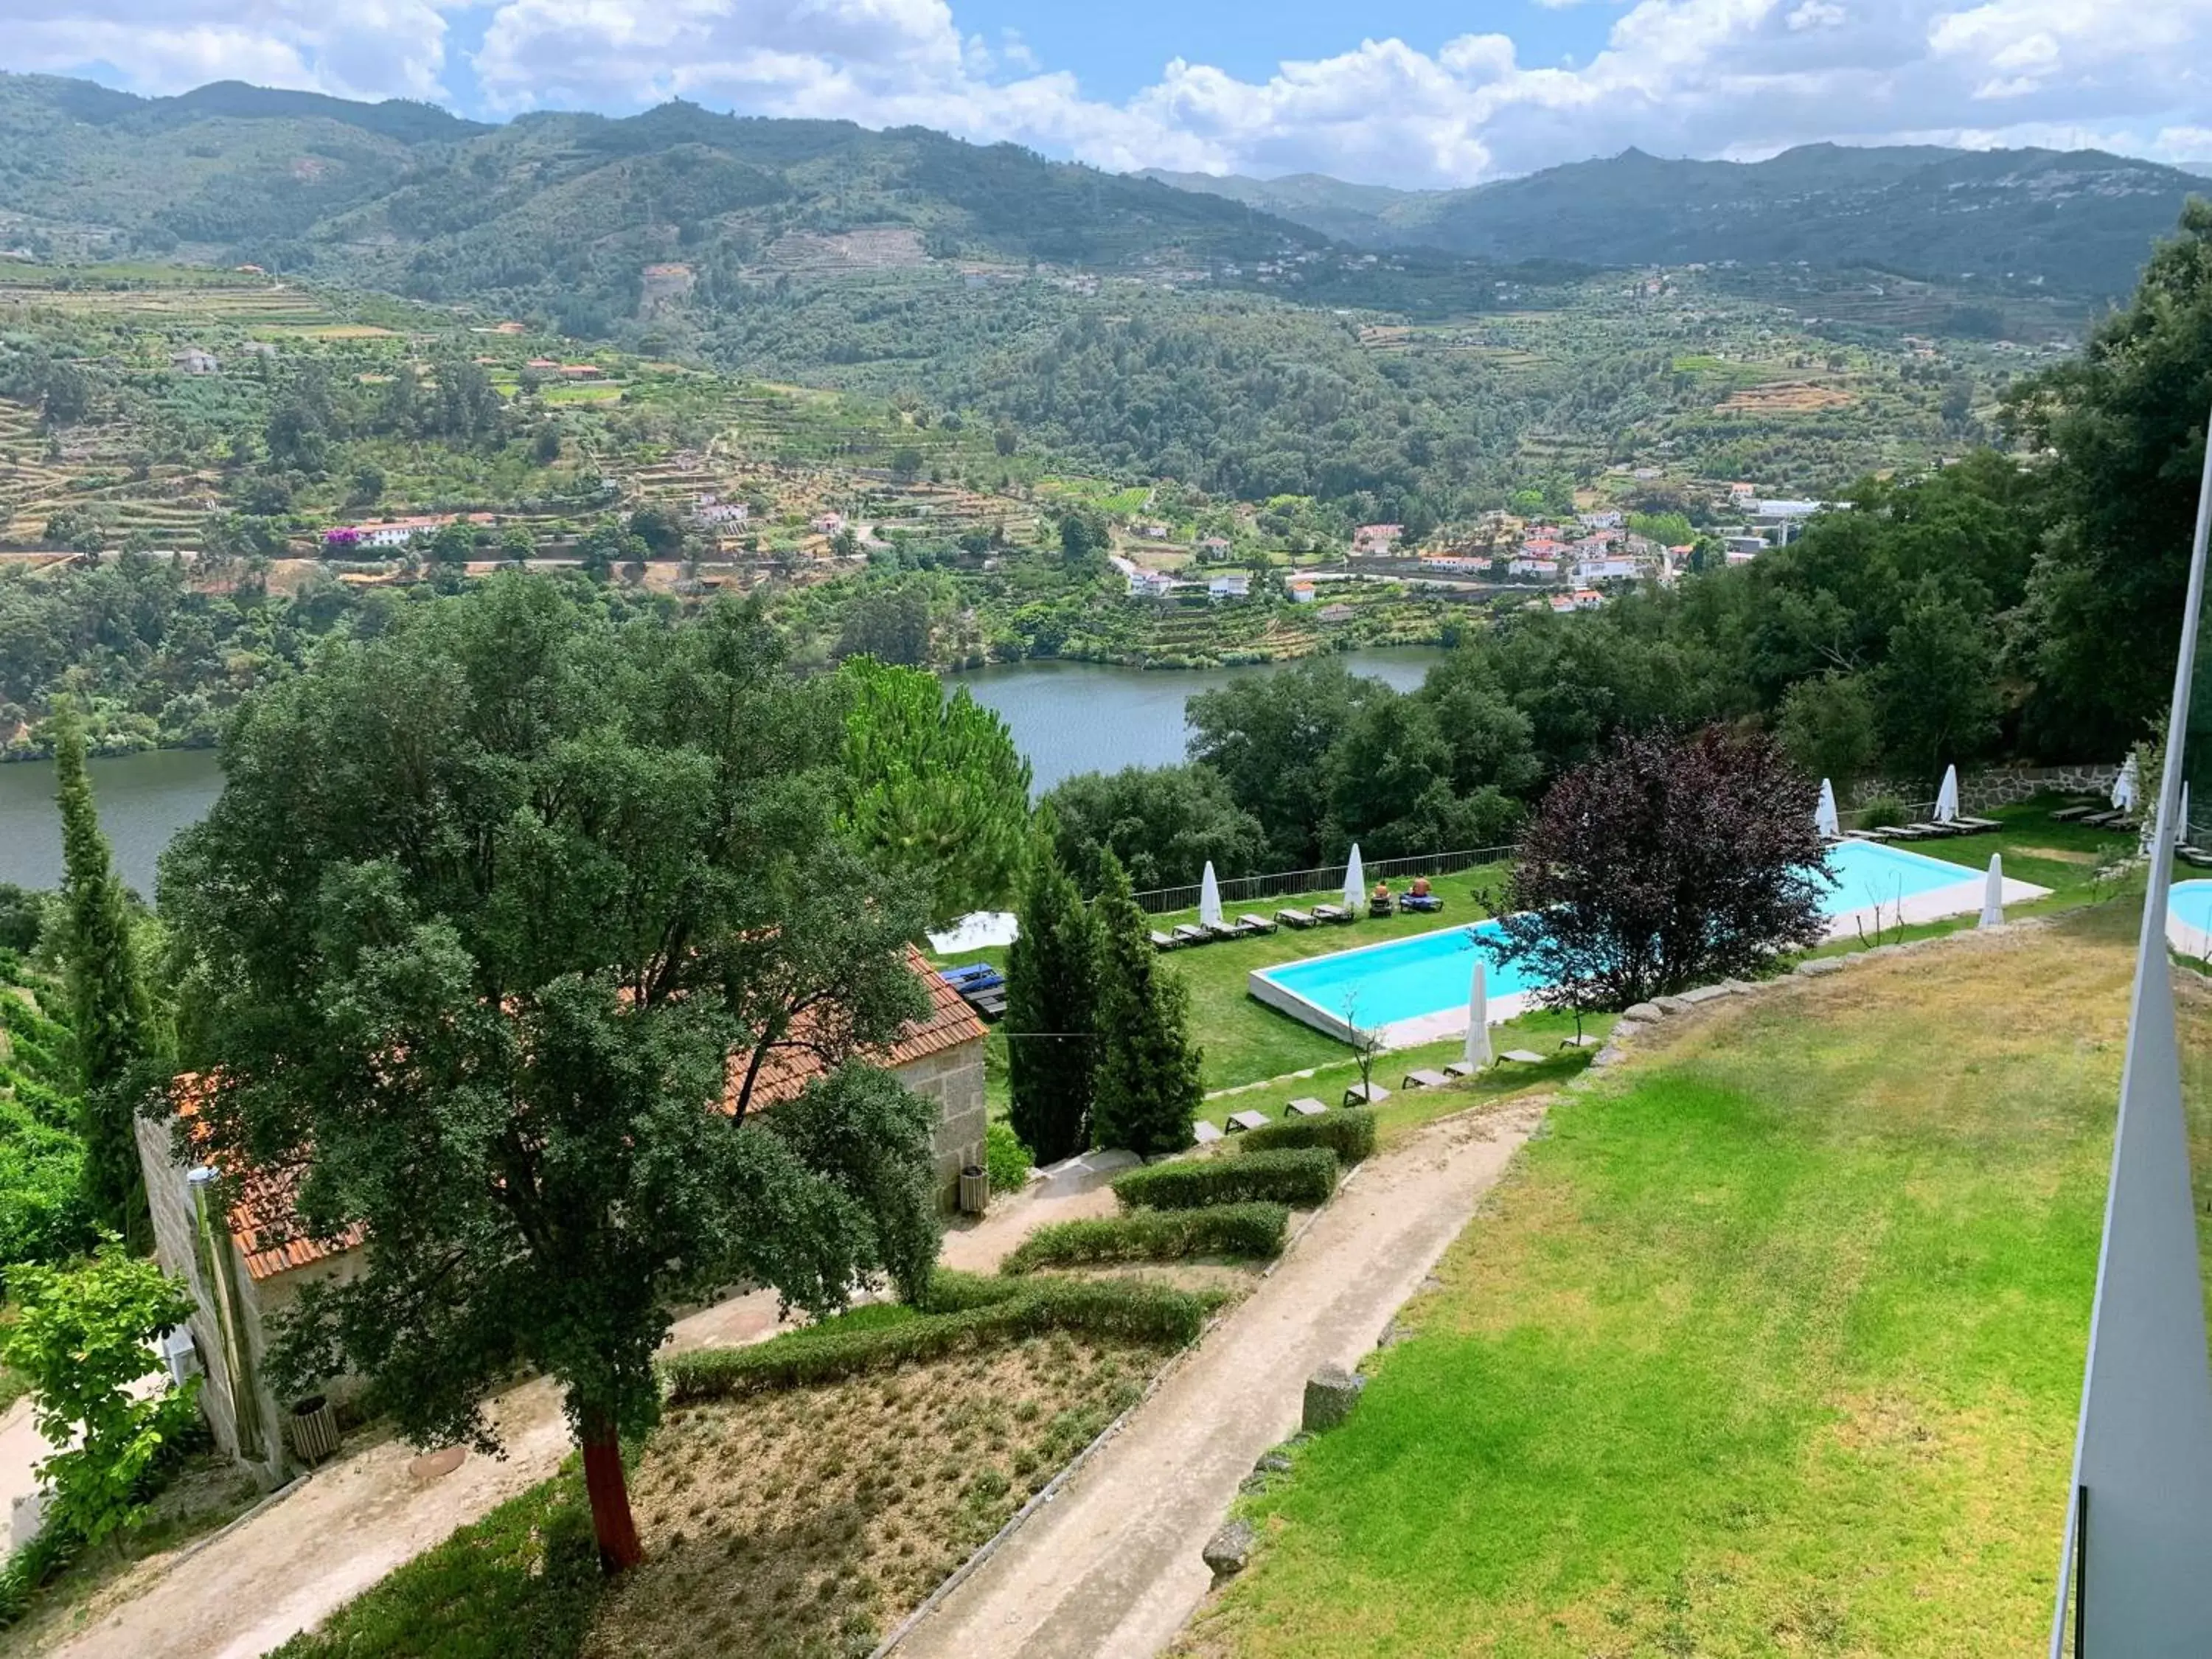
[0,646,1444,898]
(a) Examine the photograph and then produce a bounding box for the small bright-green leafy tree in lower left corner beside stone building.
[0,1237,199,1544]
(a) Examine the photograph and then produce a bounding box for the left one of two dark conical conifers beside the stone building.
[1004,836,1099,1164]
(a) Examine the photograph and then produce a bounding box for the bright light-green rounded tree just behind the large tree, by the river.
[838,657,1029,920]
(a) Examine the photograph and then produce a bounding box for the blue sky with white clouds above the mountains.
[0,0,2212,188]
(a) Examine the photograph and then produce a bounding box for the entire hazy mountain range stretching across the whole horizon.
[0,75,2201,319]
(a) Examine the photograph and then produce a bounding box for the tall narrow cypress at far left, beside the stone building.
[53,703,153,1248]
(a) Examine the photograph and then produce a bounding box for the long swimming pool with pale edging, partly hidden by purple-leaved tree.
[1245,841,2026,1046]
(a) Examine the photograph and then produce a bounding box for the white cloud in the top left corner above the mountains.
[0,0,456,97]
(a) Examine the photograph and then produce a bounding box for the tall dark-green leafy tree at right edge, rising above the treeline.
[2006,199,2212,757]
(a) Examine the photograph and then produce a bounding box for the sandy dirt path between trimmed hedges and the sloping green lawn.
[898,1104,1542,1659]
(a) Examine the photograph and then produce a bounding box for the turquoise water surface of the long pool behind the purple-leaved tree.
[1261,841,1991,1026]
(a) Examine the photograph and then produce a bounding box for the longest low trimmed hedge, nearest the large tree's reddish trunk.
[661,1274,1217,1402]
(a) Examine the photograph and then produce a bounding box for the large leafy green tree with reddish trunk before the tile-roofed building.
[161,575,936,1568]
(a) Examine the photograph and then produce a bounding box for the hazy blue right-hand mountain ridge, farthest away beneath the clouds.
[1146,144,2203,296]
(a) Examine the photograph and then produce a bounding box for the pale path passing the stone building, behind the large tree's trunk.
[38,1186,1113,1659]
